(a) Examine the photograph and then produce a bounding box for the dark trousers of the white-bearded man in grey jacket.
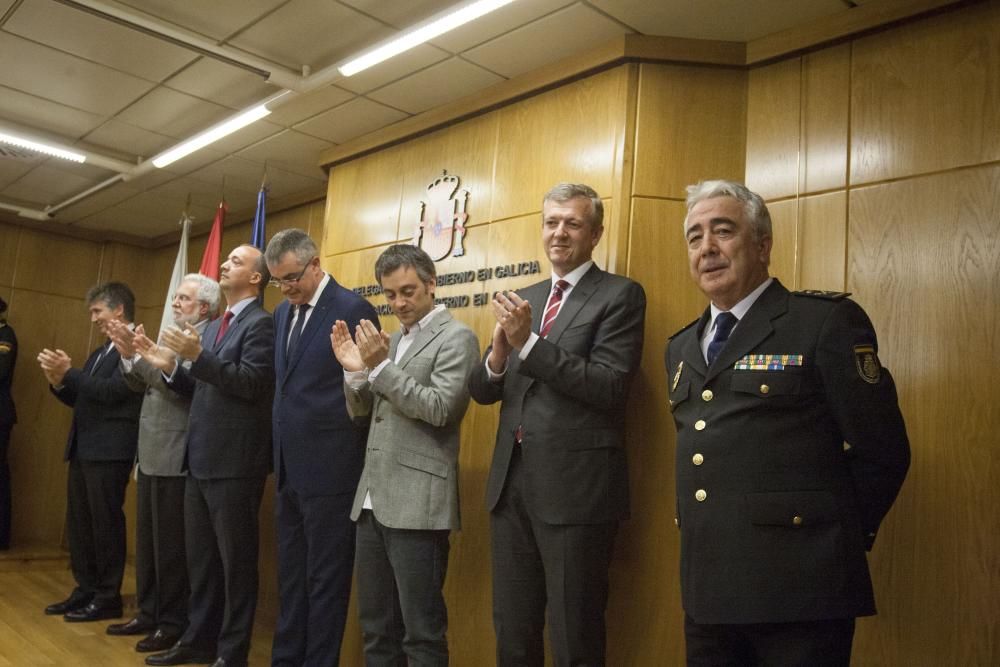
[135,470,190,635]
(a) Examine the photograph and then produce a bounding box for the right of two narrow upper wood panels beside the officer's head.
[799,44,851,192]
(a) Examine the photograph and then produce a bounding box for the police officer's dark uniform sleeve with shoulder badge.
[817,300,910,549]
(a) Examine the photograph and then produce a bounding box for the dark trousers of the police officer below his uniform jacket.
[684,614,854,667]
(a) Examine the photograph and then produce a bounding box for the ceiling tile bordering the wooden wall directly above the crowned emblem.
[369,58,504,114]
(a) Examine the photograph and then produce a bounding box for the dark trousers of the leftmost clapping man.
[66,458,132,605]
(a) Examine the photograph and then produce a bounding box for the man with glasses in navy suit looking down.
[264,229,378,667]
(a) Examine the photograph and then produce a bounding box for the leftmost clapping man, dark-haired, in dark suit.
[38,282,142,621]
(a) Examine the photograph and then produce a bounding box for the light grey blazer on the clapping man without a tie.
[344,310,479,530]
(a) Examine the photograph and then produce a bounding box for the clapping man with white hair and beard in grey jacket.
[107,273,220,653]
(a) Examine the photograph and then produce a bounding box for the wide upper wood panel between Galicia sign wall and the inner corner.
[632,63,747,199]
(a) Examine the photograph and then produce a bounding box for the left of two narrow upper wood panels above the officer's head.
[745,58,802,199]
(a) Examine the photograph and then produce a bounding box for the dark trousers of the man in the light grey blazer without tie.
[355,510,450,667]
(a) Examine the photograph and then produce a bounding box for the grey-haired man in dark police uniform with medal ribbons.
[666,181,910,665]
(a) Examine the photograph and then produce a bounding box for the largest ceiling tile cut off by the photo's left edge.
[0,32,153,116]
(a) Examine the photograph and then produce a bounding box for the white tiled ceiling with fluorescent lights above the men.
[0,0,857,238]
